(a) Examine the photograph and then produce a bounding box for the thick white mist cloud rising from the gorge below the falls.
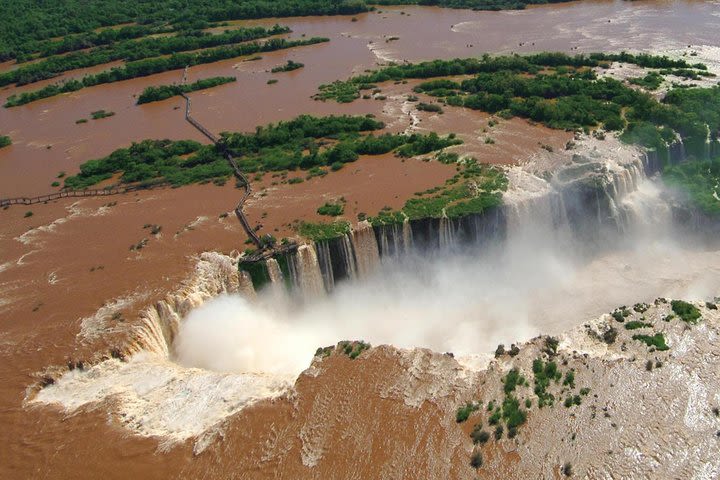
[175,180,720,374]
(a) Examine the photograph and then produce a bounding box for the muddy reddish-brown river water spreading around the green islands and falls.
[0,1,720,478]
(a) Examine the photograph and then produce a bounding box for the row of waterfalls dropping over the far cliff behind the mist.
[272,138,696,292]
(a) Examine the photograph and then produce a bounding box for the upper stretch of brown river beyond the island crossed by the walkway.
[0,1,720,196]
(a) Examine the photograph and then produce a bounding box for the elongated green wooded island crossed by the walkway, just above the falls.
[65,115,460,189]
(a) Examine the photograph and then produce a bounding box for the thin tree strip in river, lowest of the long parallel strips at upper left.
[5,38,329,107]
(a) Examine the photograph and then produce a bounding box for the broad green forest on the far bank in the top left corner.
[0,0,370,60]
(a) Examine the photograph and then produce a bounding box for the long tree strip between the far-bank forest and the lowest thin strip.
[0,25,290,87]
